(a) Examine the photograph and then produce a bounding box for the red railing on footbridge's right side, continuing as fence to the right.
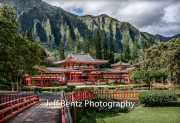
[61,90,140,123]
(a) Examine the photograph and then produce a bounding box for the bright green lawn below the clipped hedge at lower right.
[88,100,180,123]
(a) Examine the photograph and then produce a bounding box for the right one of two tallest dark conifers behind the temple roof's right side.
[102,29,108,60]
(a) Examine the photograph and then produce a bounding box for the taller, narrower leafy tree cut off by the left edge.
[0,5,18,91]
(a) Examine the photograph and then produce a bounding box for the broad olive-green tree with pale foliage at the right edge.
[136,39,180,85]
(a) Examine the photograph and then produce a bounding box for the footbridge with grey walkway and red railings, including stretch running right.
[0,90,140,123]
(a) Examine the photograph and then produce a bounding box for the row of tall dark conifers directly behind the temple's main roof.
[59,29,114,67]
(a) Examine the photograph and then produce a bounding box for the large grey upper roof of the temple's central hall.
[53,52,108,64]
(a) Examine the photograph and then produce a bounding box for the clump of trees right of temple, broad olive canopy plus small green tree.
[131,38,180,85]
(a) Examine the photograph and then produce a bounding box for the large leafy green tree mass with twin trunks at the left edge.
[0,5,47,91]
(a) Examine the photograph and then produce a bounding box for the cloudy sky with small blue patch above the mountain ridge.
[43,0,180,37]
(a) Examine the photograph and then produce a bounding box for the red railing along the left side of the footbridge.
[0,95,39,123]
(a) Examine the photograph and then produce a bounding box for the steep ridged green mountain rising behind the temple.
[0,0,180,53]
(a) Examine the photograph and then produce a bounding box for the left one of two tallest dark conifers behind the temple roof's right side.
[96,29,102,59]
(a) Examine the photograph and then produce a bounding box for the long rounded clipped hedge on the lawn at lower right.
[138,91,178,105]
